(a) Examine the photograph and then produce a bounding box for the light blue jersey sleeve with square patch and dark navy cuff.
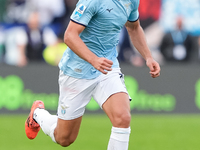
[70,0,99,26]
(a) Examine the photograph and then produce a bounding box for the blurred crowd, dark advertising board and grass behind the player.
[0,0,200,150]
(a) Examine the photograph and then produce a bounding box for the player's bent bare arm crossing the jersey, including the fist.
[64,21,113,74]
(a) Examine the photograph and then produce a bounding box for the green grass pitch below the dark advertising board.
[0,114,200,150]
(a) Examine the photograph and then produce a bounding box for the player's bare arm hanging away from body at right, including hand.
[125,19,160,78]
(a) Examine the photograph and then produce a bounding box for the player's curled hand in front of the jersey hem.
[92,57,113,74]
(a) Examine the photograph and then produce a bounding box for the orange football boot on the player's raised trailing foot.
[25,100,44,140]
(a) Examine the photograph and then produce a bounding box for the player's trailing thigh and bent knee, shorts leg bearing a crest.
[54,71,96,142]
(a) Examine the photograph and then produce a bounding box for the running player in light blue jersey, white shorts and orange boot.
[25,0,160,150]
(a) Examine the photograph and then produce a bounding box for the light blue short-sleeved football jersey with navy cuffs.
[59,0,139,79]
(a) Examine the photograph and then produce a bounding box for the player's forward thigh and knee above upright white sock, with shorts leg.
[93,69,130,126]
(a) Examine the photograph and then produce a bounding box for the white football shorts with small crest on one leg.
[57,68,130,120]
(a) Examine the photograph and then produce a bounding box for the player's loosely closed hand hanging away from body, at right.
[146,58,160,78]
